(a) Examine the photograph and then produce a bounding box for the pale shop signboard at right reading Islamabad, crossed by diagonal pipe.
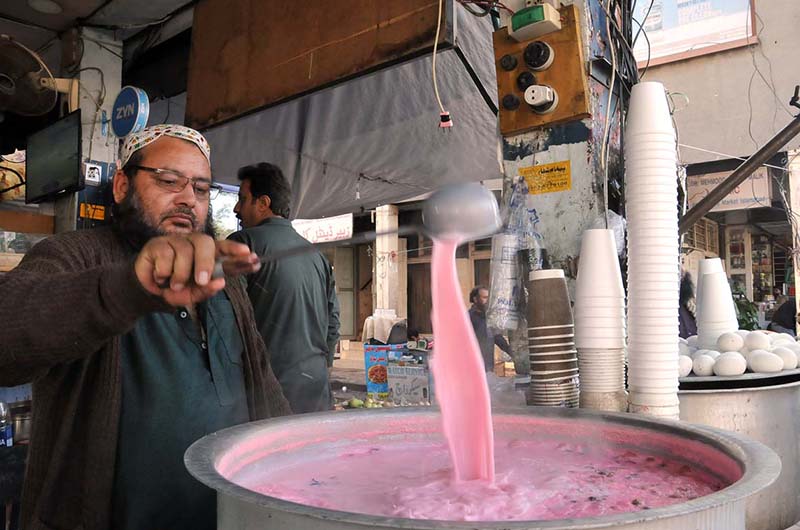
[686,167,772,212]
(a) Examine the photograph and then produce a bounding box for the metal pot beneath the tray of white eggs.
[679,382,800,530]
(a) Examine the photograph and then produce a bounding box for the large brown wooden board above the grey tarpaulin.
[186,0,453,129]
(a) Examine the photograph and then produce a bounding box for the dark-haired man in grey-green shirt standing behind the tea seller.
[229,162,339,413]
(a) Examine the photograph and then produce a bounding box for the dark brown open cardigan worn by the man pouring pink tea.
[0,228,291,530]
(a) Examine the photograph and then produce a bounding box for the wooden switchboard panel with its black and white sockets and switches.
[494,4,590,136]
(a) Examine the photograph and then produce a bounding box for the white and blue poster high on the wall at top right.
[633,0,754,67]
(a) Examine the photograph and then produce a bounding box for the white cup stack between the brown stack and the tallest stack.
[575,229,628,412]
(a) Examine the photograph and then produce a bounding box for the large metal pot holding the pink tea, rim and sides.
[185,407,780,530]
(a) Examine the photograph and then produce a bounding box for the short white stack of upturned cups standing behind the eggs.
[695,258,739,350]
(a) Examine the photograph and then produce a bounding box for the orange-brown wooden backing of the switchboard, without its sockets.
[494,5,590,136]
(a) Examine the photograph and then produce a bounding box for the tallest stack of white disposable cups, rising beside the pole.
[625,82,680,419]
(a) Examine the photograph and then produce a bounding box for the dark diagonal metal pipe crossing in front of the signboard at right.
[678,115,800,234]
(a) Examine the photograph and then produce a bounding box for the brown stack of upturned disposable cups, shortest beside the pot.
[525,269,579,407]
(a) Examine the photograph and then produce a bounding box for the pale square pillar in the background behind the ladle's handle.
[374,205,400,315]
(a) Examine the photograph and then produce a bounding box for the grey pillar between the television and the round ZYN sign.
[55,28,122,233]
